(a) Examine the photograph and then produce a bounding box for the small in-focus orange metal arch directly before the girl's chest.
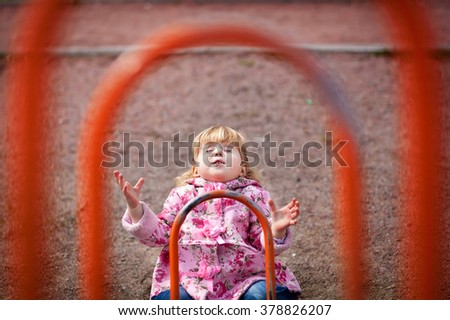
[169,190,276,300]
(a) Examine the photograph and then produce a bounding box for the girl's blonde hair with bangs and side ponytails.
[176,126,261,186]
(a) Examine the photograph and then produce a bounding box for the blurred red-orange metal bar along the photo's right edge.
[379,0,449,299]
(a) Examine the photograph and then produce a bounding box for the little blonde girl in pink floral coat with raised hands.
[114,127,300,300]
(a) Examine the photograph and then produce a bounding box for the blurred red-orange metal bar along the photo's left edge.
[5,0,64,299]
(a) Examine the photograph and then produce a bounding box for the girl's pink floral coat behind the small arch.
[122,178,300,299]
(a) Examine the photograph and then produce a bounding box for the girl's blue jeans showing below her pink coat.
[151,280,298,300]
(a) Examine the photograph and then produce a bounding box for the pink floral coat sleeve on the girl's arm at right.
[249,189,292,255]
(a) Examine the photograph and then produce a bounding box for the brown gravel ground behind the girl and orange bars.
[0,1,450,299]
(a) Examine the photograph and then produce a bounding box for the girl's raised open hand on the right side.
[268,198,300,239]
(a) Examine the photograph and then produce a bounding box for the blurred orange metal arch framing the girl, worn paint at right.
[78,25,365,299]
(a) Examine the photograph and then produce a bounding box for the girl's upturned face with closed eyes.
[195,142,242,182]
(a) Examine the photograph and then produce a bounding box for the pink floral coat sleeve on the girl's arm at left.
[122,188,183,247]
